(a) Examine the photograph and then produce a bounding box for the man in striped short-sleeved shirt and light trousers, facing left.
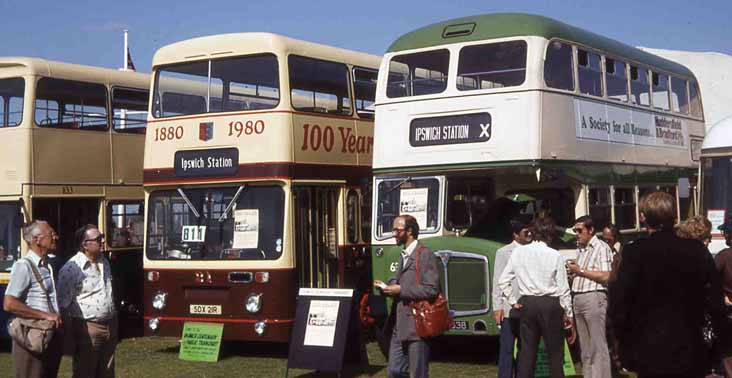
[567,215,613,378]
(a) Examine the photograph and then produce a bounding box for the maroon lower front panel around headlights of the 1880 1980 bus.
[143,269,297,342]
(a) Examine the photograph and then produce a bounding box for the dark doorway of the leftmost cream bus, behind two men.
[32,198,101,262]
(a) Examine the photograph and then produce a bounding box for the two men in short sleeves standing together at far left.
[3,220,118,378]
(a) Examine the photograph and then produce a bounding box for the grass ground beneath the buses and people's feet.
[0,337,497,378]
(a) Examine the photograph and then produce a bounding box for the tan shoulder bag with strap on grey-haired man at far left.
[8,259,56,355]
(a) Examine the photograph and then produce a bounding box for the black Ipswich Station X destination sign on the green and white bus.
[409,113,491,147]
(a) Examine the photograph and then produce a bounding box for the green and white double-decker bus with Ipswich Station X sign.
[371,14,704,335]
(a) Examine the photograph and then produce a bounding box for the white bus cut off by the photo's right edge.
[700,116,732,254]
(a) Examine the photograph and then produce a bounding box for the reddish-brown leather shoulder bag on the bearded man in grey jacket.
[409,249,453,338]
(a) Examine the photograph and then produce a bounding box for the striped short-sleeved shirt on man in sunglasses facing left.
[572,235,613,294]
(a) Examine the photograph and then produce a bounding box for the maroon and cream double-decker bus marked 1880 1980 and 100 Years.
[144,33,380,342]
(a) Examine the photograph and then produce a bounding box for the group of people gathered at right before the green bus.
[492,192,732,378]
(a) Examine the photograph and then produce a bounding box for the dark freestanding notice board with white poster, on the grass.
[285,288,353,376]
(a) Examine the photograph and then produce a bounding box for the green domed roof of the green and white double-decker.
[387,13,694,77]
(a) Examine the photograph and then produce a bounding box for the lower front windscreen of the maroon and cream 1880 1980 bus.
[147,186,285,260]
